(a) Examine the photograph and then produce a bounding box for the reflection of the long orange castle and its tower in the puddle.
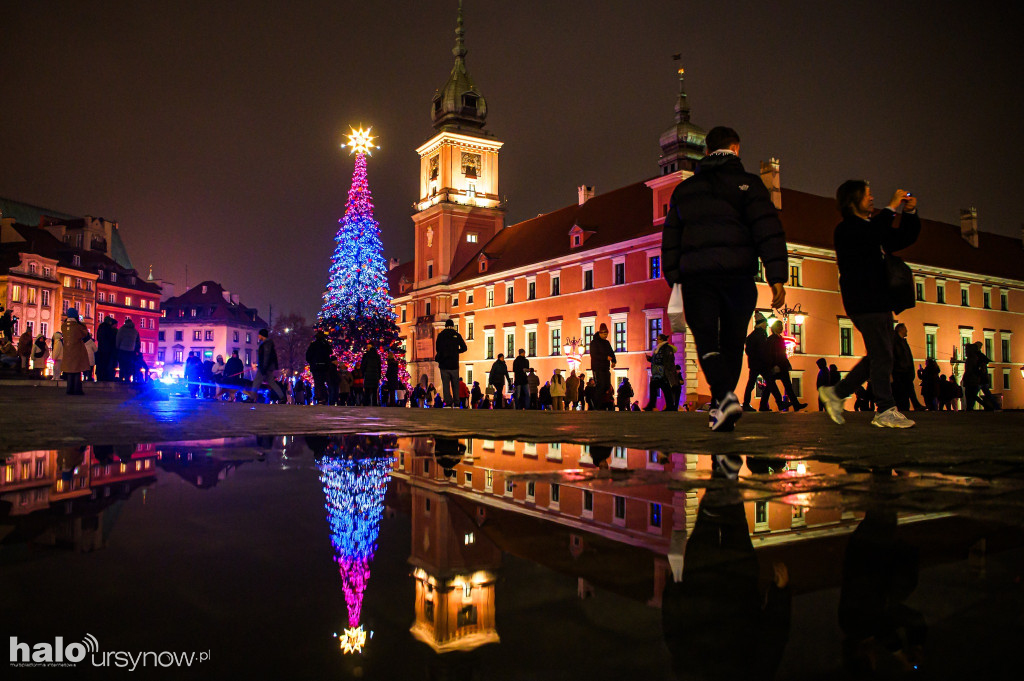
[392,437,942,614]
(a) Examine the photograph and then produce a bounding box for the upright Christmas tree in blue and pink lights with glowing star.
[316,127,409,385]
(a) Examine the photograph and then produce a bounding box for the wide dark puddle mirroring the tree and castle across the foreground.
[0,435,1024,679]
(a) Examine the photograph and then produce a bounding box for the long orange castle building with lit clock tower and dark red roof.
[389,22,1024,408]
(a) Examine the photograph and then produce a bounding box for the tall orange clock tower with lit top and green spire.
[413,0,505,296]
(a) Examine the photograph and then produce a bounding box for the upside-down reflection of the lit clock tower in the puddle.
[409,456,502,652]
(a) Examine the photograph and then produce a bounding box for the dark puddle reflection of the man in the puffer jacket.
[662,462,792,679]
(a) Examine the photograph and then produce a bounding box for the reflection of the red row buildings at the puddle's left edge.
[0,444,157,551]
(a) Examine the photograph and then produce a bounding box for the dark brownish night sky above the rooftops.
[0,0,1024,318]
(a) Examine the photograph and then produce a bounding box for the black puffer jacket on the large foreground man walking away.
[662,154,790,285]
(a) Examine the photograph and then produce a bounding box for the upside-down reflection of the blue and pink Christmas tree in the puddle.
[316,436,391,652]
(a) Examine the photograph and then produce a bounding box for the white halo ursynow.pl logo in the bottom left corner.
[10,634,210,672]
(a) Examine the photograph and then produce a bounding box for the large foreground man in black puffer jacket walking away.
[662,126,788,430]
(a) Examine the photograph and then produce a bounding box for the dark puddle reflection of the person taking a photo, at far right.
[839,510,928,673]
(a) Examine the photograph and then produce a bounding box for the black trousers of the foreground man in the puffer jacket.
[682,276,757,403]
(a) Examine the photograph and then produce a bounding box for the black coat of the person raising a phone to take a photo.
[835,209,921,314]
